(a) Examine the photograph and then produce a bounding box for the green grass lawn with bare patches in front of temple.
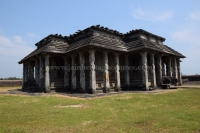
[0,88,200,133]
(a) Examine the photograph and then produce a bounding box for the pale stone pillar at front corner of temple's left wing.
[44,55,50,92]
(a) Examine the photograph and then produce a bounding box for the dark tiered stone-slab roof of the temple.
[19,25,185,63]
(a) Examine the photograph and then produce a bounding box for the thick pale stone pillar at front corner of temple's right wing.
[140,52,149,90]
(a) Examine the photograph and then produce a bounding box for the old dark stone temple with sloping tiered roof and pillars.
[18,25,185,93]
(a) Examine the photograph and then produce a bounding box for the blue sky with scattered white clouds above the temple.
[0,0,200,78]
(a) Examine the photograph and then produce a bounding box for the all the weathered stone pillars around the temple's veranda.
[23,49,181,93]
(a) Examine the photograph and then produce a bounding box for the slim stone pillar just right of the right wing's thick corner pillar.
[150,53,156,88]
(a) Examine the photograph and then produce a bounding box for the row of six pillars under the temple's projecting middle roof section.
[64,49,120,93]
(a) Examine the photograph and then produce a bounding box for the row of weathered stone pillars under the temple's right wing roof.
[140,52,182,90]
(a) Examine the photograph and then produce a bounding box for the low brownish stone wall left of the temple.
[0,80,22,87]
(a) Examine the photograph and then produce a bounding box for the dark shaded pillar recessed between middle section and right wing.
[125,55,130,90]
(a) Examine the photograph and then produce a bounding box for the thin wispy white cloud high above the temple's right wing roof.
[132,8,173,22]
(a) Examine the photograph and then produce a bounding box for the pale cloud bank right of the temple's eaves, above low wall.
[172,24,200,75]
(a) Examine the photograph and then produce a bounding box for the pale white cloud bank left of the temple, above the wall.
[0,33,36,78]
